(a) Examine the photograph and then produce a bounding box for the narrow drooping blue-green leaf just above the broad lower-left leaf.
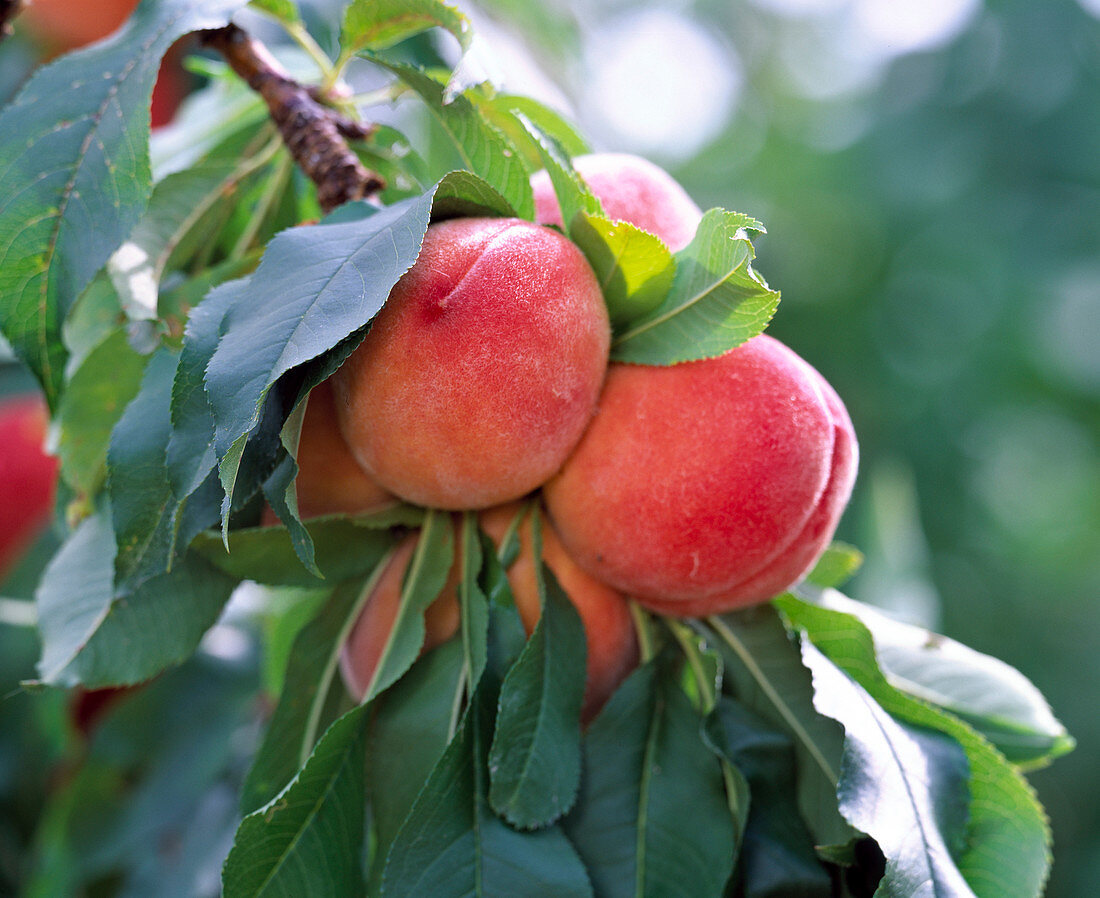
[107,349,220,587]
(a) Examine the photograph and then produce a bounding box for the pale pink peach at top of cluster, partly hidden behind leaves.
[531,153,703,252]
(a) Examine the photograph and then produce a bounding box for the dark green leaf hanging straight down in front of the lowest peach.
[488,561,586,830]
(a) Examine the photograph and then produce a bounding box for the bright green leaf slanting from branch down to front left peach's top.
[372,64,535,220]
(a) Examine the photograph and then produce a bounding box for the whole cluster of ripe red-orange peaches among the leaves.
[297,155,857,715]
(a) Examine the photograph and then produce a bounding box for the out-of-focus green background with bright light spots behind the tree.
[0,0,1100,898]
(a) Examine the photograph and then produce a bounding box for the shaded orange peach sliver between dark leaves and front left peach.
[296,381,396,518]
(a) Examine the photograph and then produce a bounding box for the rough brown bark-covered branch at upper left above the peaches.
[200,23,386,212]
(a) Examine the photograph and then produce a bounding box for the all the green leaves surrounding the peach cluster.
[0,0,1071,898]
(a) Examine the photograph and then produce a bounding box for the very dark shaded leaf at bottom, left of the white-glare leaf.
[707,696,833,898]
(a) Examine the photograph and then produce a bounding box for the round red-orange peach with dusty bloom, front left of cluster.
[333,218,611,510]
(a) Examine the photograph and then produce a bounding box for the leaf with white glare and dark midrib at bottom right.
[802,642,975,898]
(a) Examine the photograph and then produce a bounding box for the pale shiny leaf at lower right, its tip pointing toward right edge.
[800,588,1075,765]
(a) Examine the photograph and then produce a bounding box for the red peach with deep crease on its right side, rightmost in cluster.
[545,336,858,616]
